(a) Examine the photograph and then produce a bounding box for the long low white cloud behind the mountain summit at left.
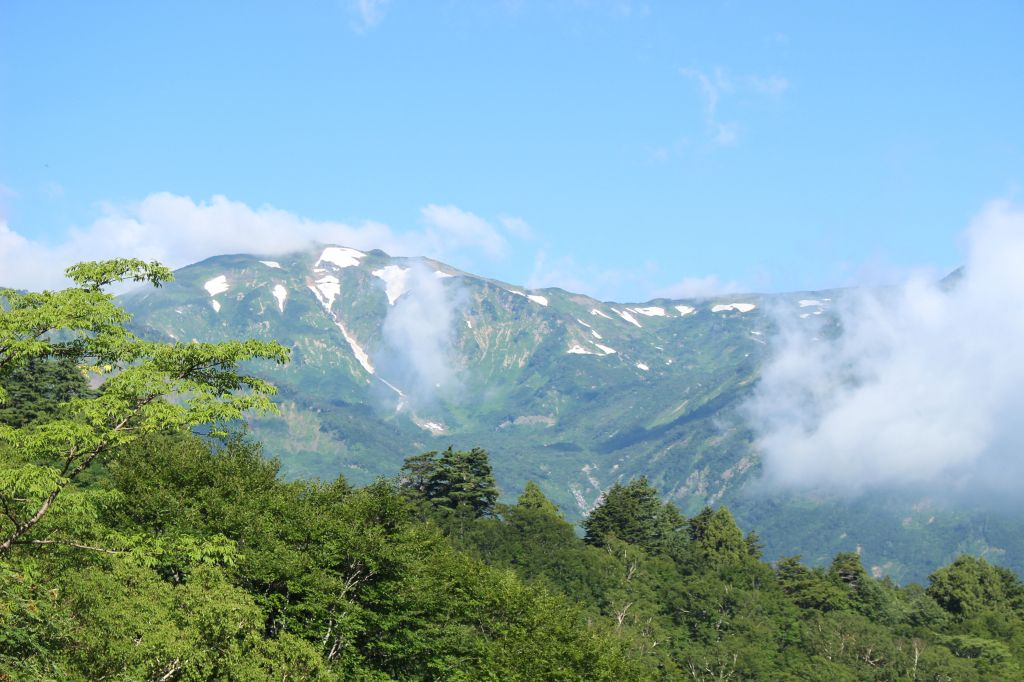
[0,193,505,289]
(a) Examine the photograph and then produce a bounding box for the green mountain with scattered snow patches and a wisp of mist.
[122,246,1024,580]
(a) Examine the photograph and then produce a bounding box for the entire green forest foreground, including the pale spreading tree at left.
[0,260,1024,681]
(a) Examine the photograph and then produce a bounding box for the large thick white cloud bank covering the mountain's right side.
[746,202,1024,501]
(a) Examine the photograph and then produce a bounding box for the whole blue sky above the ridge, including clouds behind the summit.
[0,0,1024,300]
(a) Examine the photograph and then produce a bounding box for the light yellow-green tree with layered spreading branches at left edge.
[0,259,289,556]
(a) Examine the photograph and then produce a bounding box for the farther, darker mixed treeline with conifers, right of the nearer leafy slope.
[399,440,1024,681]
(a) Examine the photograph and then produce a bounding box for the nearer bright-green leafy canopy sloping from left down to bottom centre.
[0,434,642,680]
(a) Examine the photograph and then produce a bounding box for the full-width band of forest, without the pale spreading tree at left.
[0,421,1024,680]
